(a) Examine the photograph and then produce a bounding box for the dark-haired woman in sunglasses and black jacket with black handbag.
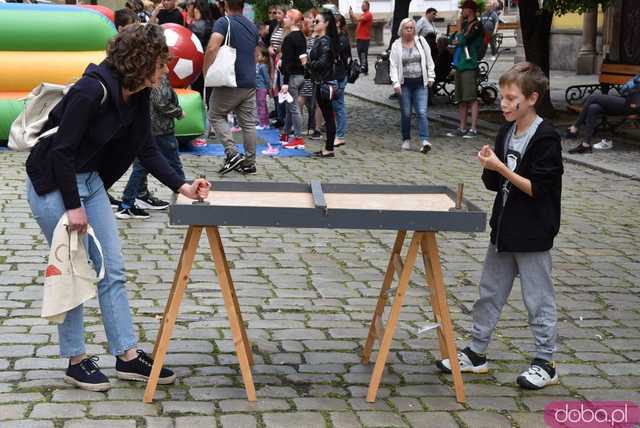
[307,12,338,158]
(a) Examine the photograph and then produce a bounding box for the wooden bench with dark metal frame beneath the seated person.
[564,64,640,132]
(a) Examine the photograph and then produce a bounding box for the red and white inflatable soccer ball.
[162,23,204,88]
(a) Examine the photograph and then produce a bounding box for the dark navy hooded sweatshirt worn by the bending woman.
[27,61,185,210]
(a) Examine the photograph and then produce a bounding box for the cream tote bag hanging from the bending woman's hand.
[40,213,104,324]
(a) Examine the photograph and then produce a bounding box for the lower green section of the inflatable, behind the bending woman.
[0,92,204,142]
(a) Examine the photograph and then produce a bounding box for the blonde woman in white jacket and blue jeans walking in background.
[389,18,436,153]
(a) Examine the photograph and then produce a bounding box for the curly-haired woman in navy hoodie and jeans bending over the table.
[26,24,209,391]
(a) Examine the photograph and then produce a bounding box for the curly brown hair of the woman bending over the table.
[107,23,170,91]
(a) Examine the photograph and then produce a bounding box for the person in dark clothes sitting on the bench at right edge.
[565,74,640,154]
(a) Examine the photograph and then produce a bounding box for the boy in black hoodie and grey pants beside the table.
[437,62,563,389]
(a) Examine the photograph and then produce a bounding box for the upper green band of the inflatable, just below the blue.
[0,8,116,51]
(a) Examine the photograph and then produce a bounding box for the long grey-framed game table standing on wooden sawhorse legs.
[144,182,486,403]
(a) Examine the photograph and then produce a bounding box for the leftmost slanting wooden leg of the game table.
[143,226,202,403]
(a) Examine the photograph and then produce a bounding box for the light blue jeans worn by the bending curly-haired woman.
[27,172,138,357]
